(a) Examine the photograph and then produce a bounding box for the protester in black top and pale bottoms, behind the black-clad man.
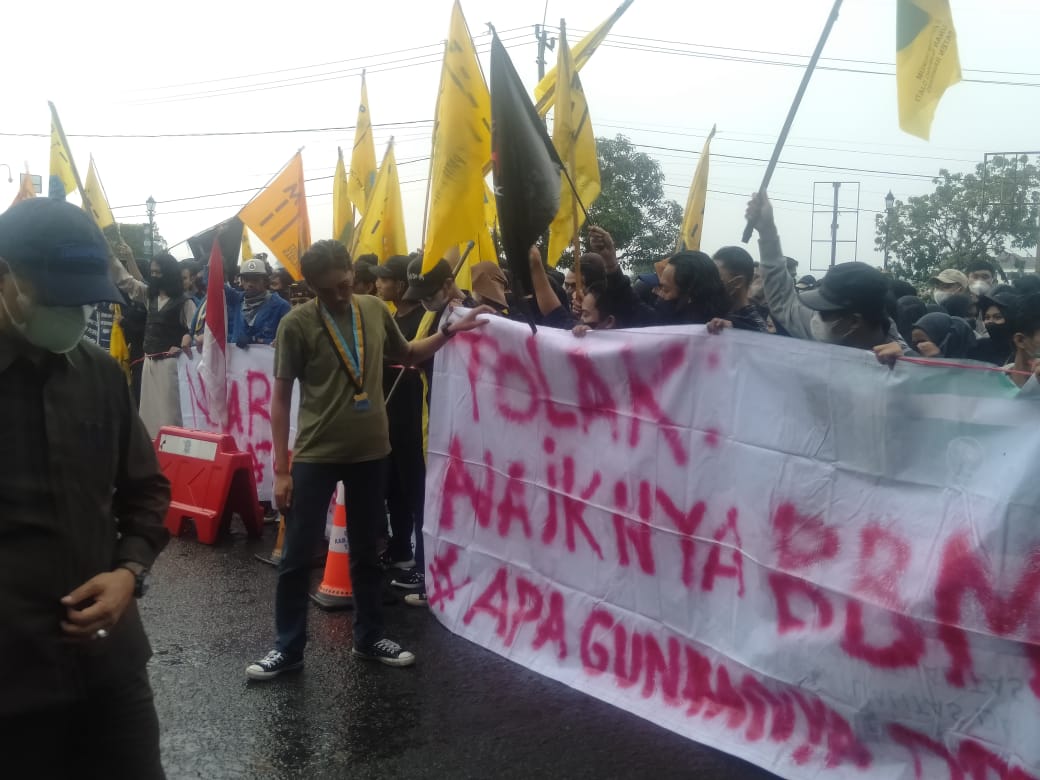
[109,252,196,439]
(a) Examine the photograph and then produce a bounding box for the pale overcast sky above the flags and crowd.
[0,0,1040,272]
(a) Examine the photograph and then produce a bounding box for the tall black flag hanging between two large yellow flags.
[491,35,563,294]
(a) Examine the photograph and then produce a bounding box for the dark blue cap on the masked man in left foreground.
[0,198,123,306]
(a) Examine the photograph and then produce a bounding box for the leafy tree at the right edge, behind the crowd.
[875,156,1040,284]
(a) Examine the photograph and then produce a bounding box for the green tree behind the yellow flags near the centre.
[560,135,682,272]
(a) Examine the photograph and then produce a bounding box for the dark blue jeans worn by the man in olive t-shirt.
[275,459,387,656]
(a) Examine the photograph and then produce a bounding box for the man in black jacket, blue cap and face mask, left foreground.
[0,199,170,780]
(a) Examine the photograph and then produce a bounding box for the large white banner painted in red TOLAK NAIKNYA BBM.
[425,319,1040,780]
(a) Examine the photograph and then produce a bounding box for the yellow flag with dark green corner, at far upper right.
[895,0,961,140]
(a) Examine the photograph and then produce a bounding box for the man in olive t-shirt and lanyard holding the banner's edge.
[245,241,489,680]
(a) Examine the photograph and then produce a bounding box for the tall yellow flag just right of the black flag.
[548,24,600,267]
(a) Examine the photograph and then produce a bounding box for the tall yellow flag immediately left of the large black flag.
[422,0,491,270]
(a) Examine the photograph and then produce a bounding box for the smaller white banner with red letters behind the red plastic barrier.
[178,344,300,501]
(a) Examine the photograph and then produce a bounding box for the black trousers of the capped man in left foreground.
[0,669,165,780]
